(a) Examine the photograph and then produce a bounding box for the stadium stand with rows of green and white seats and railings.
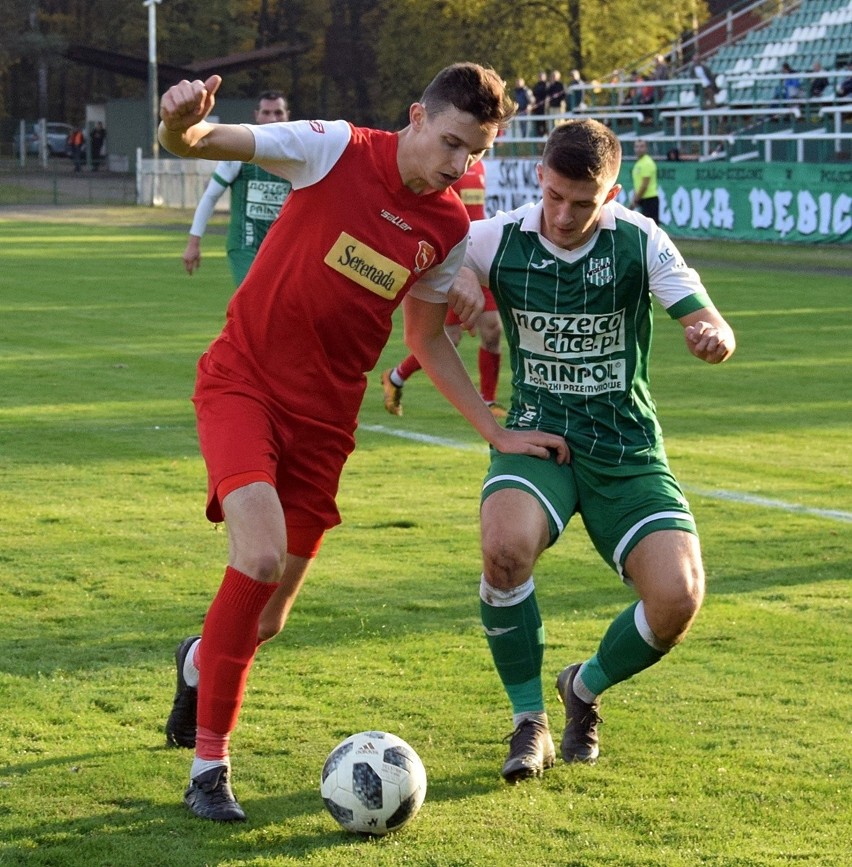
[500,0,852,162]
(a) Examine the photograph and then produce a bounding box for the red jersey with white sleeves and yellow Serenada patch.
[210,121,469,424]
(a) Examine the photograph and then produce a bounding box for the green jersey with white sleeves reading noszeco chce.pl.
[465,202,710,472]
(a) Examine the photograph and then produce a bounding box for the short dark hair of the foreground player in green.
[541,118,621,182]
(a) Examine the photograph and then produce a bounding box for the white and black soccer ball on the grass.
[320,732,426,836]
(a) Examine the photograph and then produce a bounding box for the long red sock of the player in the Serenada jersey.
[198,566,278,758]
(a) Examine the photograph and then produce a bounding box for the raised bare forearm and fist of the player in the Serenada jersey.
[157,75,254,162]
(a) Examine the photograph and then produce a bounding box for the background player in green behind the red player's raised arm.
[183,90,290,286]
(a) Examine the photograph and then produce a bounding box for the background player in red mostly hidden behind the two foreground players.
[382,162,507,418]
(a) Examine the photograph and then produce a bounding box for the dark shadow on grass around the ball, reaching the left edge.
[0,750,506,867]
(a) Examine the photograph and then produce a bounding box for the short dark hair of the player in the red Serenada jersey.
[420,63,516,127]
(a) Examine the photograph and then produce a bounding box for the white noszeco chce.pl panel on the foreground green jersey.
[512,309,624,363]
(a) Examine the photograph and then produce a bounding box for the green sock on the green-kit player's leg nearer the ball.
[479,591,544,714]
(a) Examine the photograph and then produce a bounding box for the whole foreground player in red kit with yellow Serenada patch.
[159,63,568,821]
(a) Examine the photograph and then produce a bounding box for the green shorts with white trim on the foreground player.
[482,448,698,580]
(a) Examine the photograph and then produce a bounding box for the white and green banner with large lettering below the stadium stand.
[486,159,852,244]
